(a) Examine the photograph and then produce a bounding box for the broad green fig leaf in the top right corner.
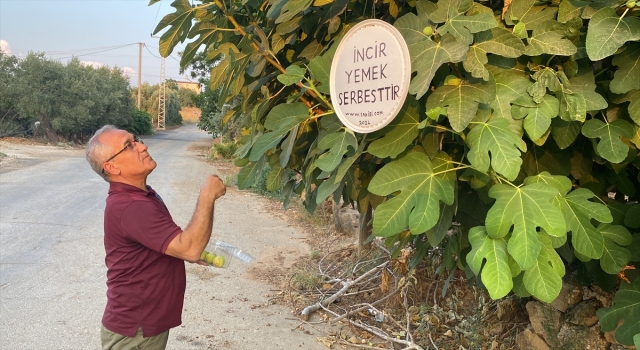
[587,7,640,61]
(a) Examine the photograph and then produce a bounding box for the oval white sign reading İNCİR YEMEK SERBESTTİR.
[330,19,411,133]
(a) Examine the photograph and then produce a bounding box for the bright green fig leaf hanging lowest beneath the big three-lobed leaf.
[524,232,565,303]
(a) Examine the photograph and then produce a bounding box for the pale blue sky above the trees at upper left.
[0,0,195,86]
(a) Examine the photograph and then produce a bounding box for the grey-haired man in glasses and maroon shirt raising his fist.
[86,125,226,350]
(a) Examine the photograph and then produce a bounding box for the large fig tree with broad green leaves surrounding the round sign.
[150,0,640,345]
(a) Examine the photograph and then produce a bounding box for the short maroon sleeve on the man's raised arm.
[121,201,182,254]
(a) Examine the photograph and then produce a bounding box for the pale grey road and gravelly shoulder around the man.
[0,125,326,350]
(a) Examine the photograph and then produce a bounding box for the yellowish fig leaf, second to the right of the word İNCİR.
[463,28,524,80]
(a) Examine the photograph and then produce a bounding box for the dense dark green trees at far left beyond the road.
[0,53,150,140]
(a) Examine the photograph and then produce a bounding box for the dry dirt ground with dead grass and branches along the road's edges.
[0,138,527,350]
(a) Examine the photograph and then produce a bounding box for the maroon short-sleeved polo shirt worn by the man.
[102,182,186,337]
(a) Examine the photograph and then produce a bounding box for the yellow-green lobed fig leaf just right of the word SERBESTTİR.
[427,78,496,132]
